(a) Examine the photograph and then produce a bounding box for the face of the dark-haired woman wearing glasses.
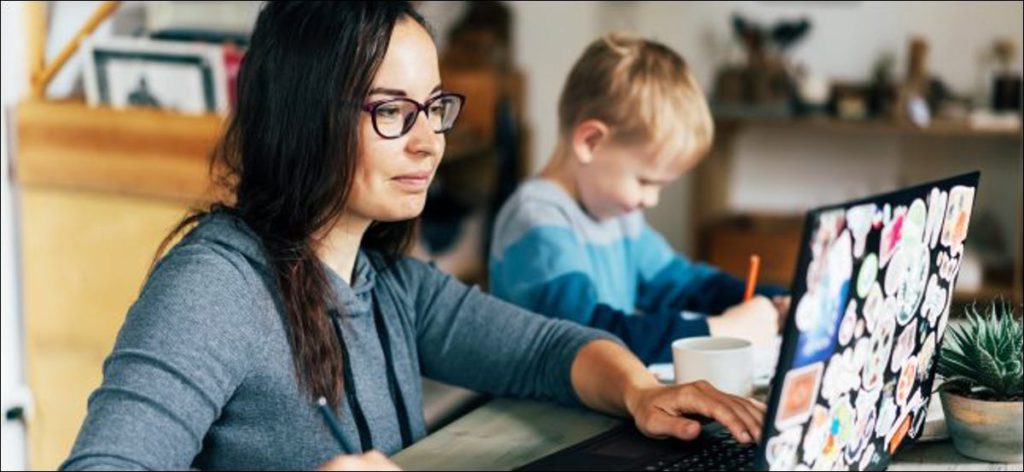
[346,18,444,221]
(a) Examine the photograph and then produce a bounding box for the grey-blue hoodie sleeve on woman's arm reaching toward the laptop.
[404,255,618,404]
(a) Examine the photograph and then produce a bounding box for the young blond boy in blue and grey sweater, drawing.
[489,35,788,363]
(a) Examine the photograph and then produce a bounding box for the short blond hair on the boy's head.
[558,34,714,158]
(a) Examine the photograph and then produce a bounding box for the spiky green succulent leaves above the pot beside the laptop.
[937,301,1024,401]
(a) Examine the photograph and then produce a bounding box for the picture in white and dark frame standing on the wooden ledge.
[82,38,227,115]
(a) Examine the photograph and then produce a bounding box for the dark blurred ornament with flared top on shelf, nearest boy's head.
[712,14,811,117]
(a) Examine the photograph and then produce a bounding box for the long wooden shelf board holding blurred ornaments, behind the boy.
[716,118,1021,141]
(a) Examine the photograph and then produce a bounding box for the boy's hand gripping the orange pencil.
[708,295,788,346]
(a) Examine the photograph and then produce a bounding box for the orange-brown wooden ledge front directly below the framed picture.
[13,100,223,203]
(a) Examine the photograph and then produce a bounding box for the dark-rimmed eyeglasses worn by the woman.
[362,93,466,139]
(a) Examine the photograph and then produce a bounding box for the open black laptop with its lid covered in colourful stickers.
[521,172,979,470]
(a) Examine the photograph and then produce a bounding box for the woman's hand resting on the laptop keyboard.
[626,381,766,443]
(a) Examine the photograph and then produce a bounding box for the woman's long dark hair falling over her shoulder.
[158,1,429,406]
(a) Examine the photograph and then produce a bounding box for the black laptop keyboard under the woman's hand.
[641,429,758,471]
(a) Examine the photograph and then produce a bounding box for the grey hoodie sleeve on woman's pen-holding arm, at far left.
[61,246,256,470]
